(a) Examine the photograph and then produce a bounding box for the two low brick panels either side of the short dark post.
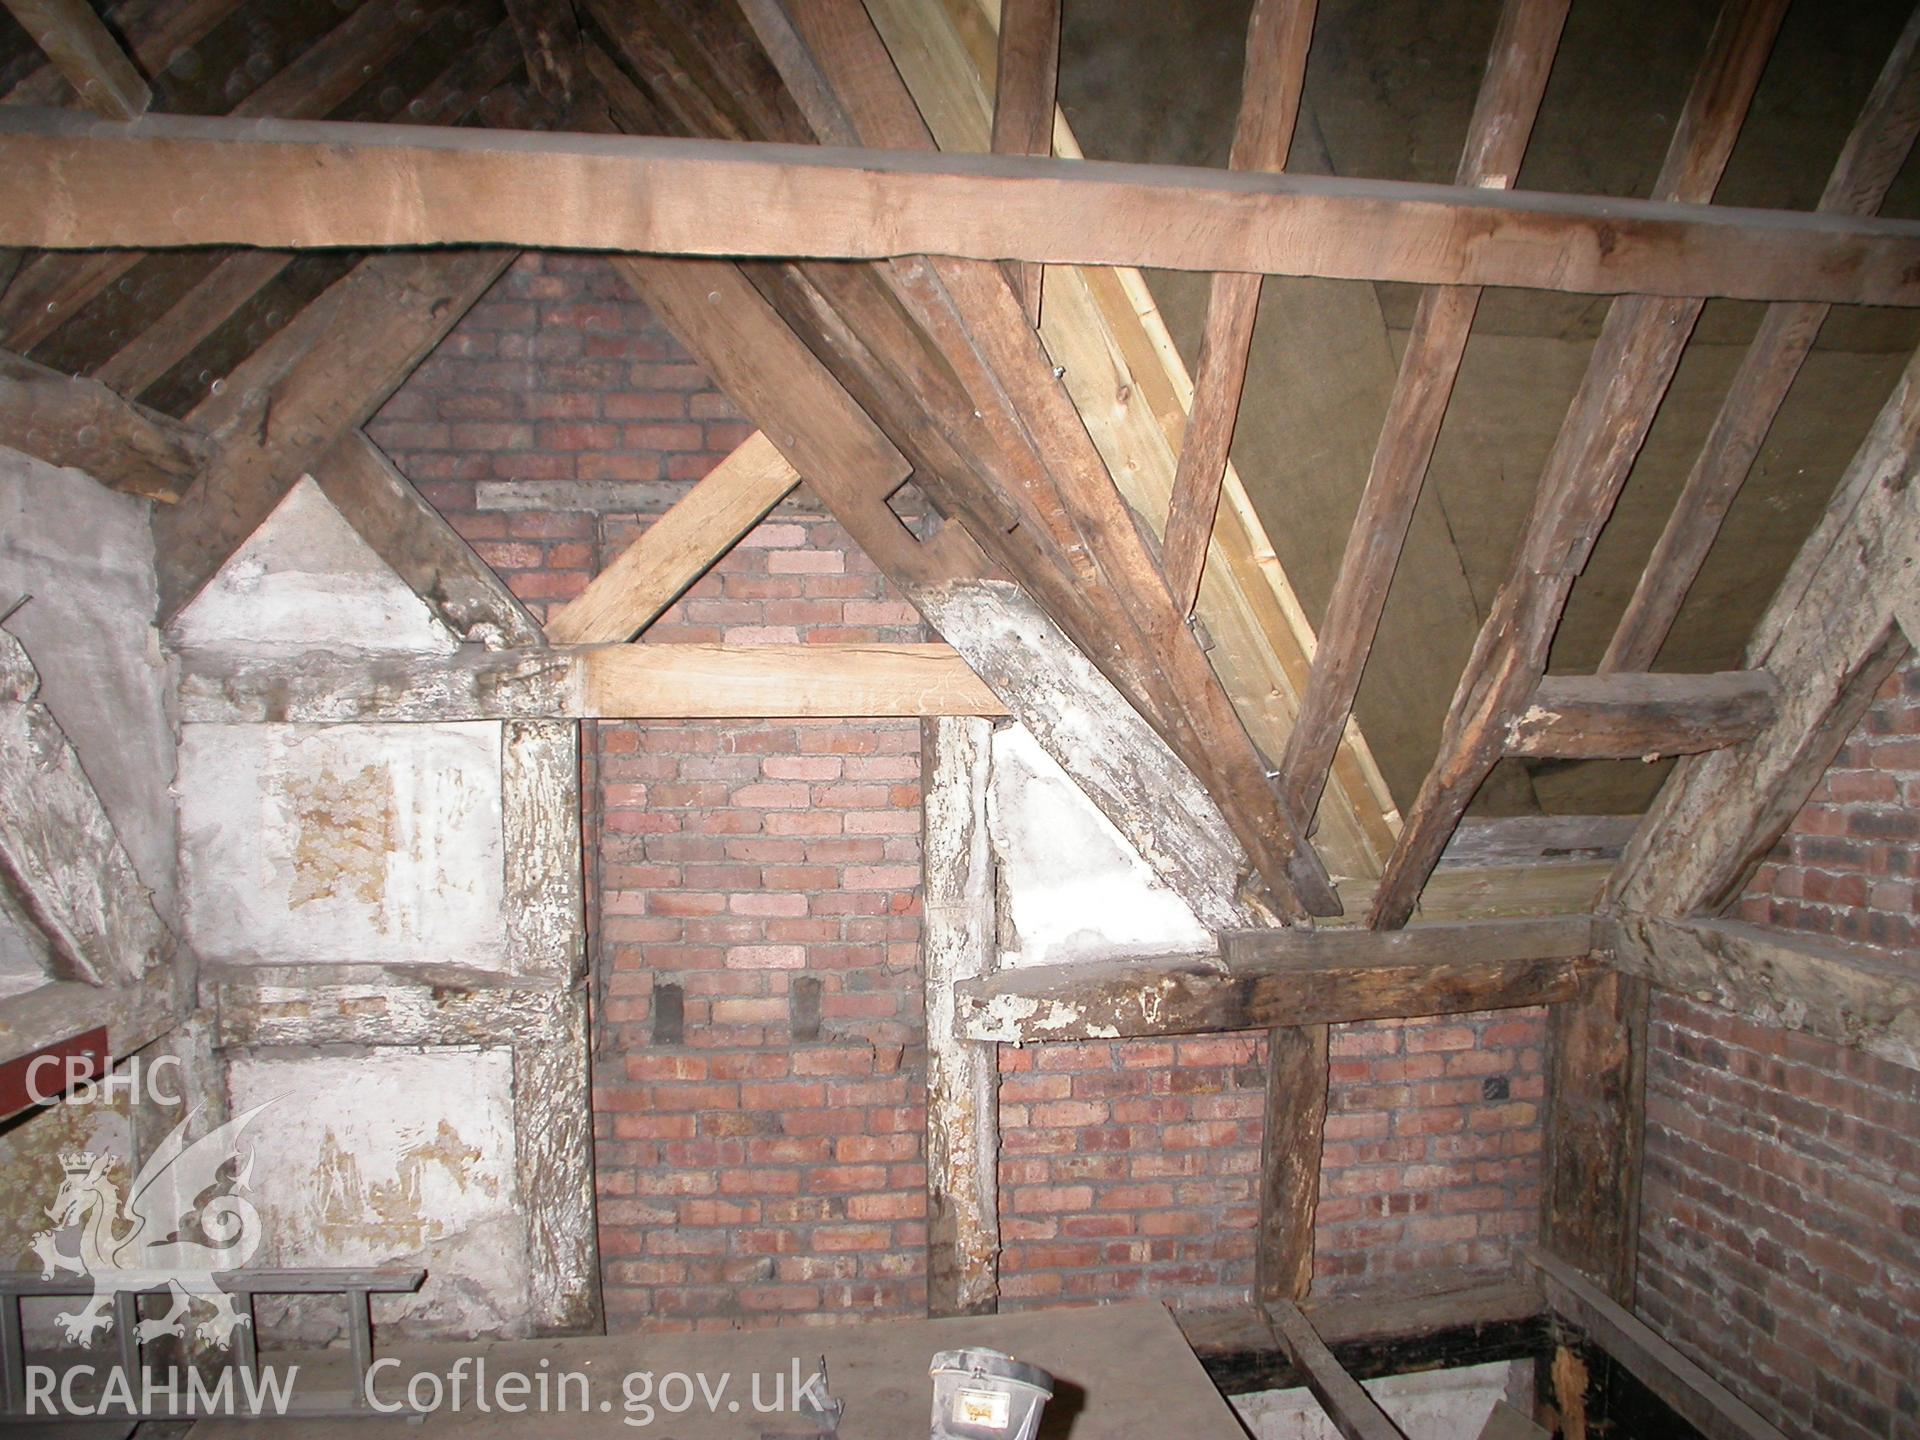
[1000,1010,1546,1306]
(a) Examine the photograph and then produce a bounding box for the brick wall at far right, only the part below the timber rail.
[1638,995,1920,1440]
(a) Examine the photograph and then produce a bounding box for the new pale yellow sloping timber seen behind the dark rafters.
[868,0,1398,881]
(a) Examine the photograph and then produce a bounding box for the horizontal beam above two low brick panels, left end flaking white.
[954,916,1592,1044]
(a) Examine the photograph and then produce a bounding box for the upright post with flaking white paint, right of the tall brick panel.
[920,718,1000,1315]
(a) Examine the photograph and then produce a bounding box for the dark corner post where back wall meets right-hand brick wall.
[1540,972,1649,1306]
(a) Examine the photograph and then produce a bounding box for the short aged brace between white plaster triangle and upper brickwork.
[313,428,541,649]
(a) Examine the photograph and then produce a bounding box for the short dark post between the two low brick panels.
[1254,1025,1327,1304]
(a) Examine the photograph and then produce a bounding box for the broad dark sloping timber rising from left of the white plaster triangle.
[154,250,513,618]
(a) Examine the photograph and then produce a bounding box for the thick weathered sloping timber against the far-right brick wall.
[1609,341,1920,918]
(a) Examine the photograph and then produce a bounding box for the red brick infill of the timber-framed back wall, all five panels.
[369,255,1544,1329]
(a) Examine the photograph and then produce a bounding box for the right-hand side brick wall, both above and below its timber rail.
[1638,662,1920,1440]
